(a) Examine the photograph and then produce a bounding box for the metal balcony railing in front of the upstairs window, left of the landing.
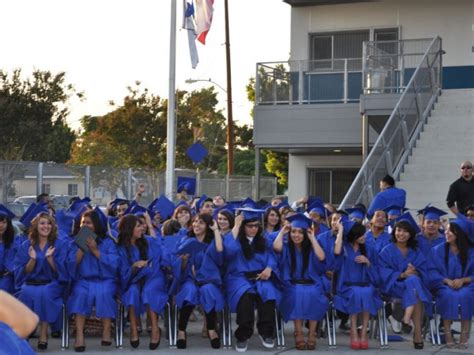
[255,58,362,105]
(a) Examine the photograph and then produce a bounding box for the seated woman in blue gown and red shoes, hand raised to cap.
[334,220,382,349]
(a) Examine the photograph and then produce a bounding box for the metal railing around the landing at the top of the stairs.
[362,38,432,94]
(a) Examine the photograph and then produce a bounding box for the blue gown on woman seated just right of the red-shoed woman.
[378,243,432,311]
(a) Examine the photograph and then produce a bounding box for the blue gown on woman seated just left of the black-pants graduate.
[173,237,225,313]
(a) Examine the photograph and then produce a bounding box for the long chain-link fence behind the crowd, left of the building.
[0,161,277,207]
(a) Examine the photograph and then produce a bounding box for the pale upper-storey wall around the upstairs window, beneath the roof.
[291,0,474,66]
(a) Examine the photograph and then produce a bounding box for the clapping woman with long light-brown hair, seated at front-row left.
[14,212,67,350]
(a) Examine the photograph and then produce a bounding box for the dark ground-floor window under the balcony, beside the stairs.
[308,168,359,205]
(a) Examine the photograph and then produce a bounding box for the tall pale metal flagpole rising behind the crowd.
[165,0,176,200]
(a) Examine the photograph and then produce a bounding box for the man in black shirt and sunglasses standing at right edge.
[446,160,474,214]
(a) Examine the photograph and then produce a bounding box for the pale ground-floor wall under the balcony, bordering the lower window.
[288,154,361,201]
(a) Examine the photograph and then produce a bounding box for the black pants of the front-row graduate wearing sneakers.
[235,292,275,341]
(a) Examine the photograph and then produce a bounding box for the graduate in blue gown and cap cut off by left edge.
[0,204,16,294]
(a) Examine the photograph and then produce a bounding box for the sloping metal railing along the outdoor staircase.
[341,37,443,208]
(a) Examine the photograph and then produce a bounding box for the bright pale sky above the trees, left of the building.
[0,0,290,129]
